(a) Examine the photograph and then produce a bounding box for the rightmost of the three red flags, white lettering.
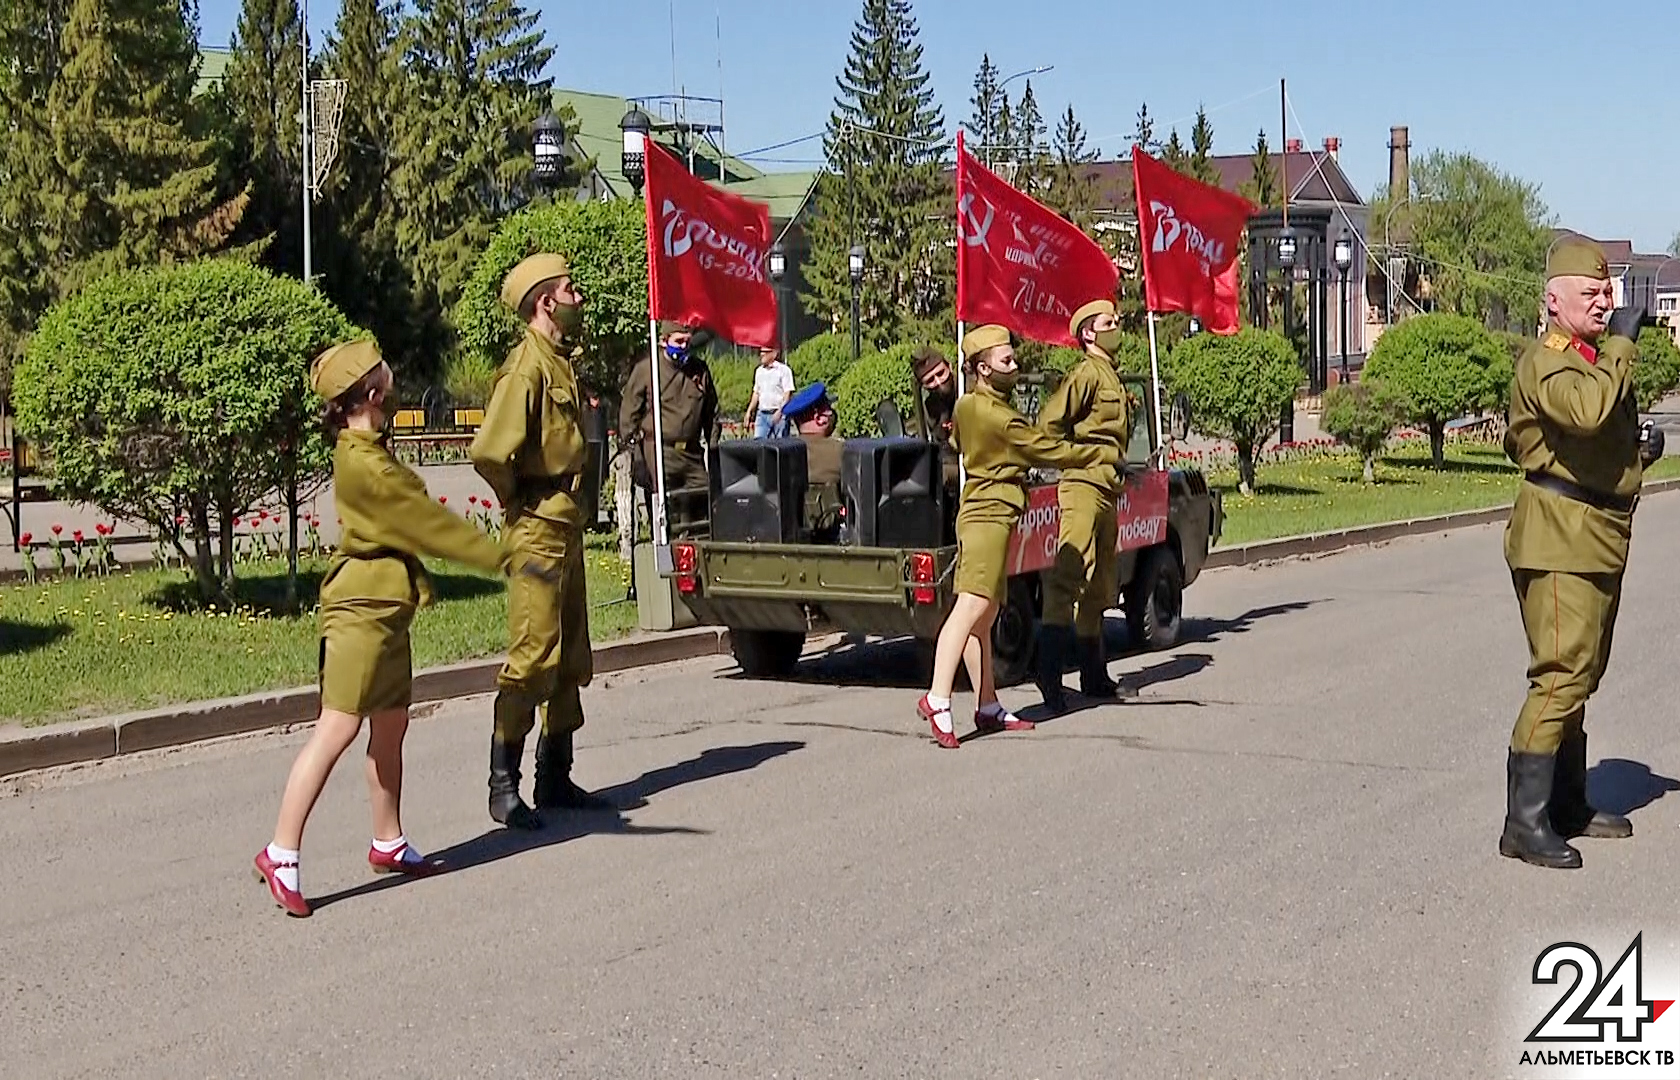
[1132,144,1255,334]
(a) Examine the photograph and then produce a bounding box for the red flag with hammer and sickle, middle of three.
[956,131,1121,344]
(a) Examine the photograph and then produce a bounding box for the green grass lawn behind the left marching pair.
[0,534,637,724]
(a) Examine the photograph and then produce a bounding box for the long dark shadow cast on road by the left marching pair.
[309,742,805,909]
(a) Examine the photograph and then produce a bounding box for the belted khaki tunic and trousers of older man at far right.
[1505,333,1643,754]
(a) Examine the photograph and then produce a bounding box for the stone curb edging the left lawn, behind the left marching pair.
[0,627,729,776]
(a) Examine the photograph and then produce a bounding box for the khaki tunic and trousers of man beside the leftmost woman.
[469,322,593,725]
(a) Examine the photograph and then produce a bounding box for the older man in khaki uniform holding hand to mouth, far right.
[1499,237,1660,868]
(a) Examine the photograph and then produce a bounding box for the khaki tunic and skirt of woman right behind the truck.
[951,383,1121,600]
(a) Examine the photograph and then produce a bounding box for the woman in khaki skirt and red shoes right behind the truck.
[916,326,1119,749]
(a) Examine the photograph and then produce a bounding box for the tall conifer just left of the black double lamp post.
[391,0,554,367]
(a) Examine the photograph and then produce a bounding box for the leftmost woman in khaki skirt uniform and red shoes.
[255,341,547,917]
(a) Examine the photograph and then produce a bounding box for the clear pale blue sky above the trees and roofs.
[200,0,1680,252]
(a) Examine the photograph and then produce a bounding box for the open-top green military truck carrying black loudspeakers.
[667,376,1225,685]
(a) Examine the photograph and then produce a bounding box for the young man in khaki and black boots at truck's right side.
[1038,301,1137,712]
